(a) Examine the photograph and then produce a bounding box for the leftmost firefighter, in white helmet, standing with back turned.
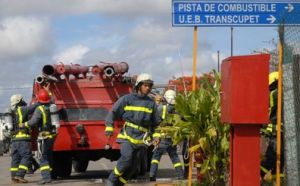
[10,94,38,183]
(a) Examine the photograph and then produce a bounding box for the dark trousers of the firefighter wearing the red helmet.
[38,138,54,181]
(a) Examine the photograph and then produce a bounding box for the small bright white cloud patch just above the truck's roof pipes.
[53,45,90,64]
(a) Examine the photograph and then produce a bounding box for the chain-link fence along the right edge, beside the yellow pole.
[278,1,300,186]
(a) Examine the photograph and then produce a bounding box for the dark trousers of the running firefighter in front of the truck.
[107,141,146,186]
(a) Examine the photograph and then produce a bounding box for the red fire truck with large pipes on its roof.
[33,62,147,177]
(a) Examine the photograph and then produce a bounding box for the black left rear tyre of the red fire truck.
[51,152,72,179]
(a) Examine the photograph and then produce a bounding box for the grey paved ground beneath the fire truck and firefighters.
[0,154,192,186]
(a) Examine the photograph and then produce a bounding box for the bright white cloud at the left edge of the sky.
[0,17,51,59]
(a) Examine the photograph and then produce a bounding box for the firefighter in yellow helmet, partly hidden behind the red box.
[261,72,284,182]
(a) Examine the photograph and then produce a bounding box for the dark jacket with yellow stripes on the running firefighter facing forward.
[105,93,161,145]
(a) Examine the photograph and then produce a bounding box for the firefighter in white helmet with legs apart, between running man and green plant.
[150,90,184,181]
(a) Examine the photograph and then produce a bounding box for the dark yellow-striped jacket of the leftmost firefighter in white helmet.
[12,103,39,141]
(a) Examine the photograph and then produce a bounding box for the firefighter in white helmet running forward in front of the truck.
[105,73,160,186]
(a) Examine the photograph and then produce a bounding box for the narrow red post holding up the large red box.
[230,124,260,186]
